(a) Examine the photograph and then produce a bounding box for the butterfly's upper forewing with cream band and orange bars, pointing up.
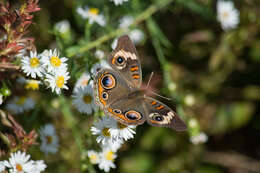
[108,35,142,88]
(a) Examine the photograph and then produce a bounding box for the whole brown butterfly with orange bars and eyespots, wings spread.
[94,35,187,131]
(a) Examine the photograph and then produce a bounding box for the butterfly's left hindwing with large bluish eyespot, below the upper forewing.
[94,69,131,110]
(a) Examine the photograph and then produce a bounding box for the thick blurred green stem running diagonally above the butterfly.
[66,0,173,57]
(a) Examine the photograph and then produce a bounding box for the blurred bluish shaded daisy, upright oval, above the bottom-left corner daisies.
[39,124,59,154]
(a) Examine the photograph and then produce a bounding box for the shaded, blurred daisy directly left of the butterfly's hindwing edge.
[72,85,97,114]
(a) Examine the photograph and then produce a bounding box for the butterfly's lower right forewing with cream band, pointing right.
[143,96,187,131]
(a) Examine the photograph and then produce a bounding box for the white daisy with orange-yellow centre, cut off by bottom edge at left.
[4,151,34,173]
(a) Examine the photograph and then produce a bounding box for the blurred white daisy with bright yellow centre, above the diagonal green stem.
[77,6,106,26]
